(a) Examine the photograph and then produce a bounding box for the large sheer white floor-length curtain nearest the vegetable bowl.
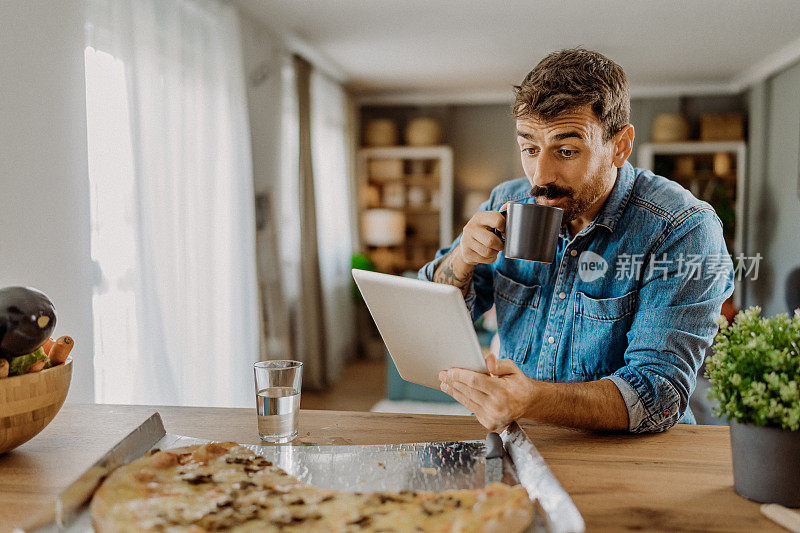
[86,0,259,407]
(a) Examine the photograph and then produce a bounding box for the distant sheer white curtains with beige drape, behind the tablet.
[276,57,355,388]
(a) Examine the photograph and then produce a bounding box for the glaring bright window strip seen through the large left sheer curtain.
[84,47,139,403]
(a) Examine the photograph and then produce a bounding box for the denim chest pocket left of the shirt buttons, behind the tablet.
[494,271,541,363]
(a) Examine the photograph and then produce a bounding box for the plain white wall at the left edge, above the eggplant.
[0,0,94,402]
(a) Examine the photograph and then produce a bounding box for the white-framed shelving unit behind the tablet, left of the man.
[358,146,453,274]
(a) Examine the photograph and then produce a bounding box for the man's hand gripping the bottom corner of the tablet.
[439,353,534,432]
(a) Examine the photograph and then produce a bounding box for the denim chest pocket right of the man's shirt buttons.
[570,290,637,377]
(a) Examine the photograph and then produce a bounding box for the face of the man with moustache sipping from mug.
[517,106,616,222]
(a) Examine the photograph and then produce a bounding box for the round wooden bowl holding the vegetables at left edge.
[0,357,72,453]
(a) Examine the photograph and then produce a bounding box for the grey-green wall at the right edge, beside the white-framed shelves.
[746,62,800,315]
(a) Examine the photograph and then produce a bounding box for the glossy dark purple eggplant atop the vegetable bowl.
[0,287,56,359]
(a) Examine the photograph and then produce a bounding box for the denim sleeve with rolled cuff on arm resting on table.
[603,210,733,433]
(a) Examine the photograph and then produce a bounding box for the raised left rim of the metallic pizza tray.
[25,412,167,531]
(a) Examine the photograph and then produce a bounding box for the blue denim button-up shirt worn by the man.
[419,162,733,433]
